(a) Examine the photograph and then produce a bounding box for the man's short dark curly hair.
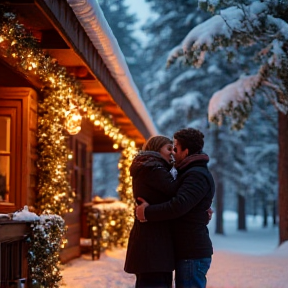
[173,128,204,155]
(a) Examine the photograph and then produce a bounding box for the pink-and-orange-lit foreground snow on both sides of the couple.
[61,243,288,288]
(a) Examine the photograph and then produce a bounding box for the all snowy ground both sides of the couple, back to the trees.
[61,212,288,288]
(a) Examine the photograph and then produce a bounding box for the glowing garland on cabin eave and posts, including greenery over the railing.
[0,4,136,287]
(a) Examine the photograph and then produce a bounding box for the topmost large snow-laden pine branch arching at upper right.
[167,1,288,66]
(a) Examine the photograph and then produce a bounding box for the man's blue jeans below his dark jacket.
[175,257,211,288]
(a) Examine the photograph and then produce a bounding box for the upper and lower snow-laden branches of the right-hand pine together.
[167,0,288,129]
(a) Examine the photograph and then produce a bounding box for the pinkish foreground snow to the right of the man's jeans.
[207,243,288,288]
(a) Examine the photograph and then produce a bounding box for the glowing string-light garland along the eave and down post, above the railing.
[0,5,136,216]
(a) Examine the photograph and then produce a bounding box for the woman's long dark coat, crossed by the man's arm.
[124,151,177,274]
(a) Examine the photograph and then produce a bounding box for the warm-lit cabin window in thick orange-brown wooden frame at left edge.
[0,87,37,213]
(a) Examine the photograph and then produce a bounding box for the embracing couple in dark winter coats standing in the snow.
[124,128,215,288]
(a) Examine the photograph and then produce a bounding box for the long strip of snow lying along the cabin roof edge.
[67,0,158,135]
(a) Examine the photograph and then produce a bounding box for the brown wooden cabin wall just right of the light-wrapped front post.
[60,119,94,263]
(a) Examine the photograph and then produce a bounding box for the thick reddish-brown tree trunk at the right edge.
[278,112,288,245]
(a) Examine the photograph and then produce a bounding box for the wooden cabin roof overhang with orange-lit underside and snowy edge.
[0,0,157,150]
